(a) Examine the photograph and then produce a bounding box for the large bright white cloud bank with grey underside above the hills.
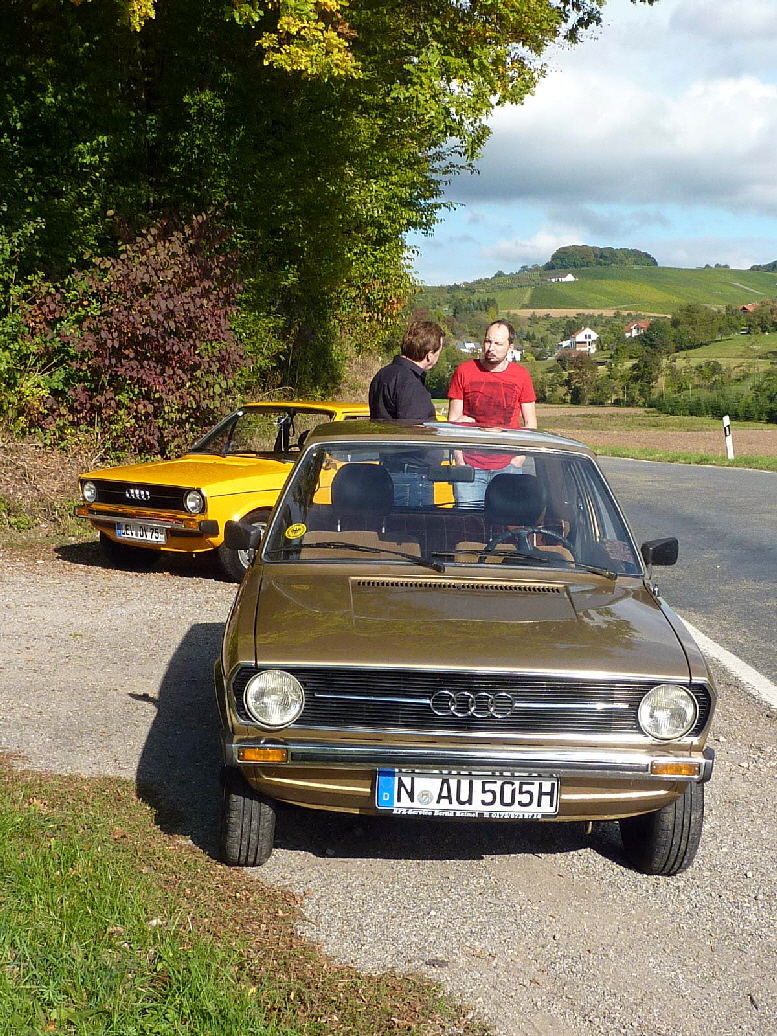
[449,73,777,215]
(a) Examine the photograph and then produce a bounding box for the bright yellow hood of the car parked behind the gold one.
[81,454,292,496]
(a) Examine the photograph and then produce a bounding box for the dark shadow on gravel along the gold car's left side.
[137,623,224,857]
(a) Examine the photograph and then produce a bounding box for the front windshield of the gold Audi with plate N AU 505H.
[262,442,642,576]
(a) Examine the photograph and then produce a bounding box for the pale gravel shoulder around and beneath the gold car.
[0,544,777,1036]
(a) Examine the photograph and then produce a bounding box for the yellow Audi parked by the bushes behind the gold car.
[76,402,370,582]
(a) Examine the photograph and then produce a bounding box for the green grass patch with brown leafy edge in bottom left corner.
[0,761,484,1036]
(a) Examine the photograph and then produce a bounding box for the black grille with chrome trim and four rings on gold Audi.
[232,666,712,737]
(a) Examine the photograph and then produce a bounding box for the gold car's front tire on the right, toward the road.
[620,784,704,876]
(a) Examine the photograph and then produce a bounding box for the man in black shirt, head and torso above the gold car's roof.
[370,320,445,422]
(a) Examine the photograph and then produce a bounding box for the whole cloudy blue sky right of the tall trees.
[408,0,777,284]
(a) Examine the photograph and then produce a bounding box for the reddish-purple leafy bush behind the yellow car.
[27,215,244,454]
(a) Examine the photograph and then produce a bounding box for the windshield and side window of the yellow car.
[190,404,334,457]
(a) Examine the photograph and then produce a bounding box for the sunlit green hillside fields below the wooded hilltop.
[419,266,777,313]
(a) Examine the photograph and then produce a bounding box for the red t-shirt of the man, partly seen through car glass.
[448,359,537,469]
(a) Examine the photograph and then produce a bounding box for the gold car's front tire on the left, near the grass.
[221,767,276,867]
